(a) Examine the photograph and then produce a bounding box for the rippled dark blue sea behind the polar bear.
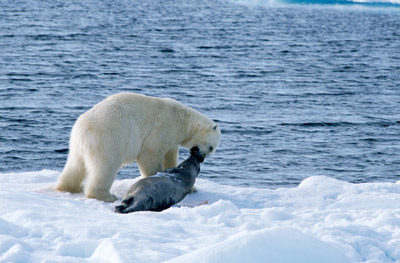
[0,0,400,188]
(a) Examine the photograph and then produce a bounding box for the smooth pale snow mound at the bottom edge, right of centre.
[168,228,350,263]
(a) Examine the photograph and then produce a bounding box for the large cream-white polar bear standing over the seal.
[56,93,221,202]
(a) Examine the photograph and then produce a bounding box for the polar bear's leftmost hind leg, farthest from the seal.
[56,154,86,193]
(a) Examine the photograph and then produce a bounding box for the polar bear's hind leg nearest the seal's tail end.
[85,163,119,202]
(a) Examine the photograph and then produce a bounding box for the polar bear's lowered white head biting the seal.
[188,122,221,156]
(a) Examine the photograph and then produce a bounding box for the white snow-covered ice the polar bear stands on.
[0,170,400,263]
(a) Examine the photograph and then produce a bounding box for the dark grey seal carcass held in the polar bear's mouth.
[115,147,204,213]
